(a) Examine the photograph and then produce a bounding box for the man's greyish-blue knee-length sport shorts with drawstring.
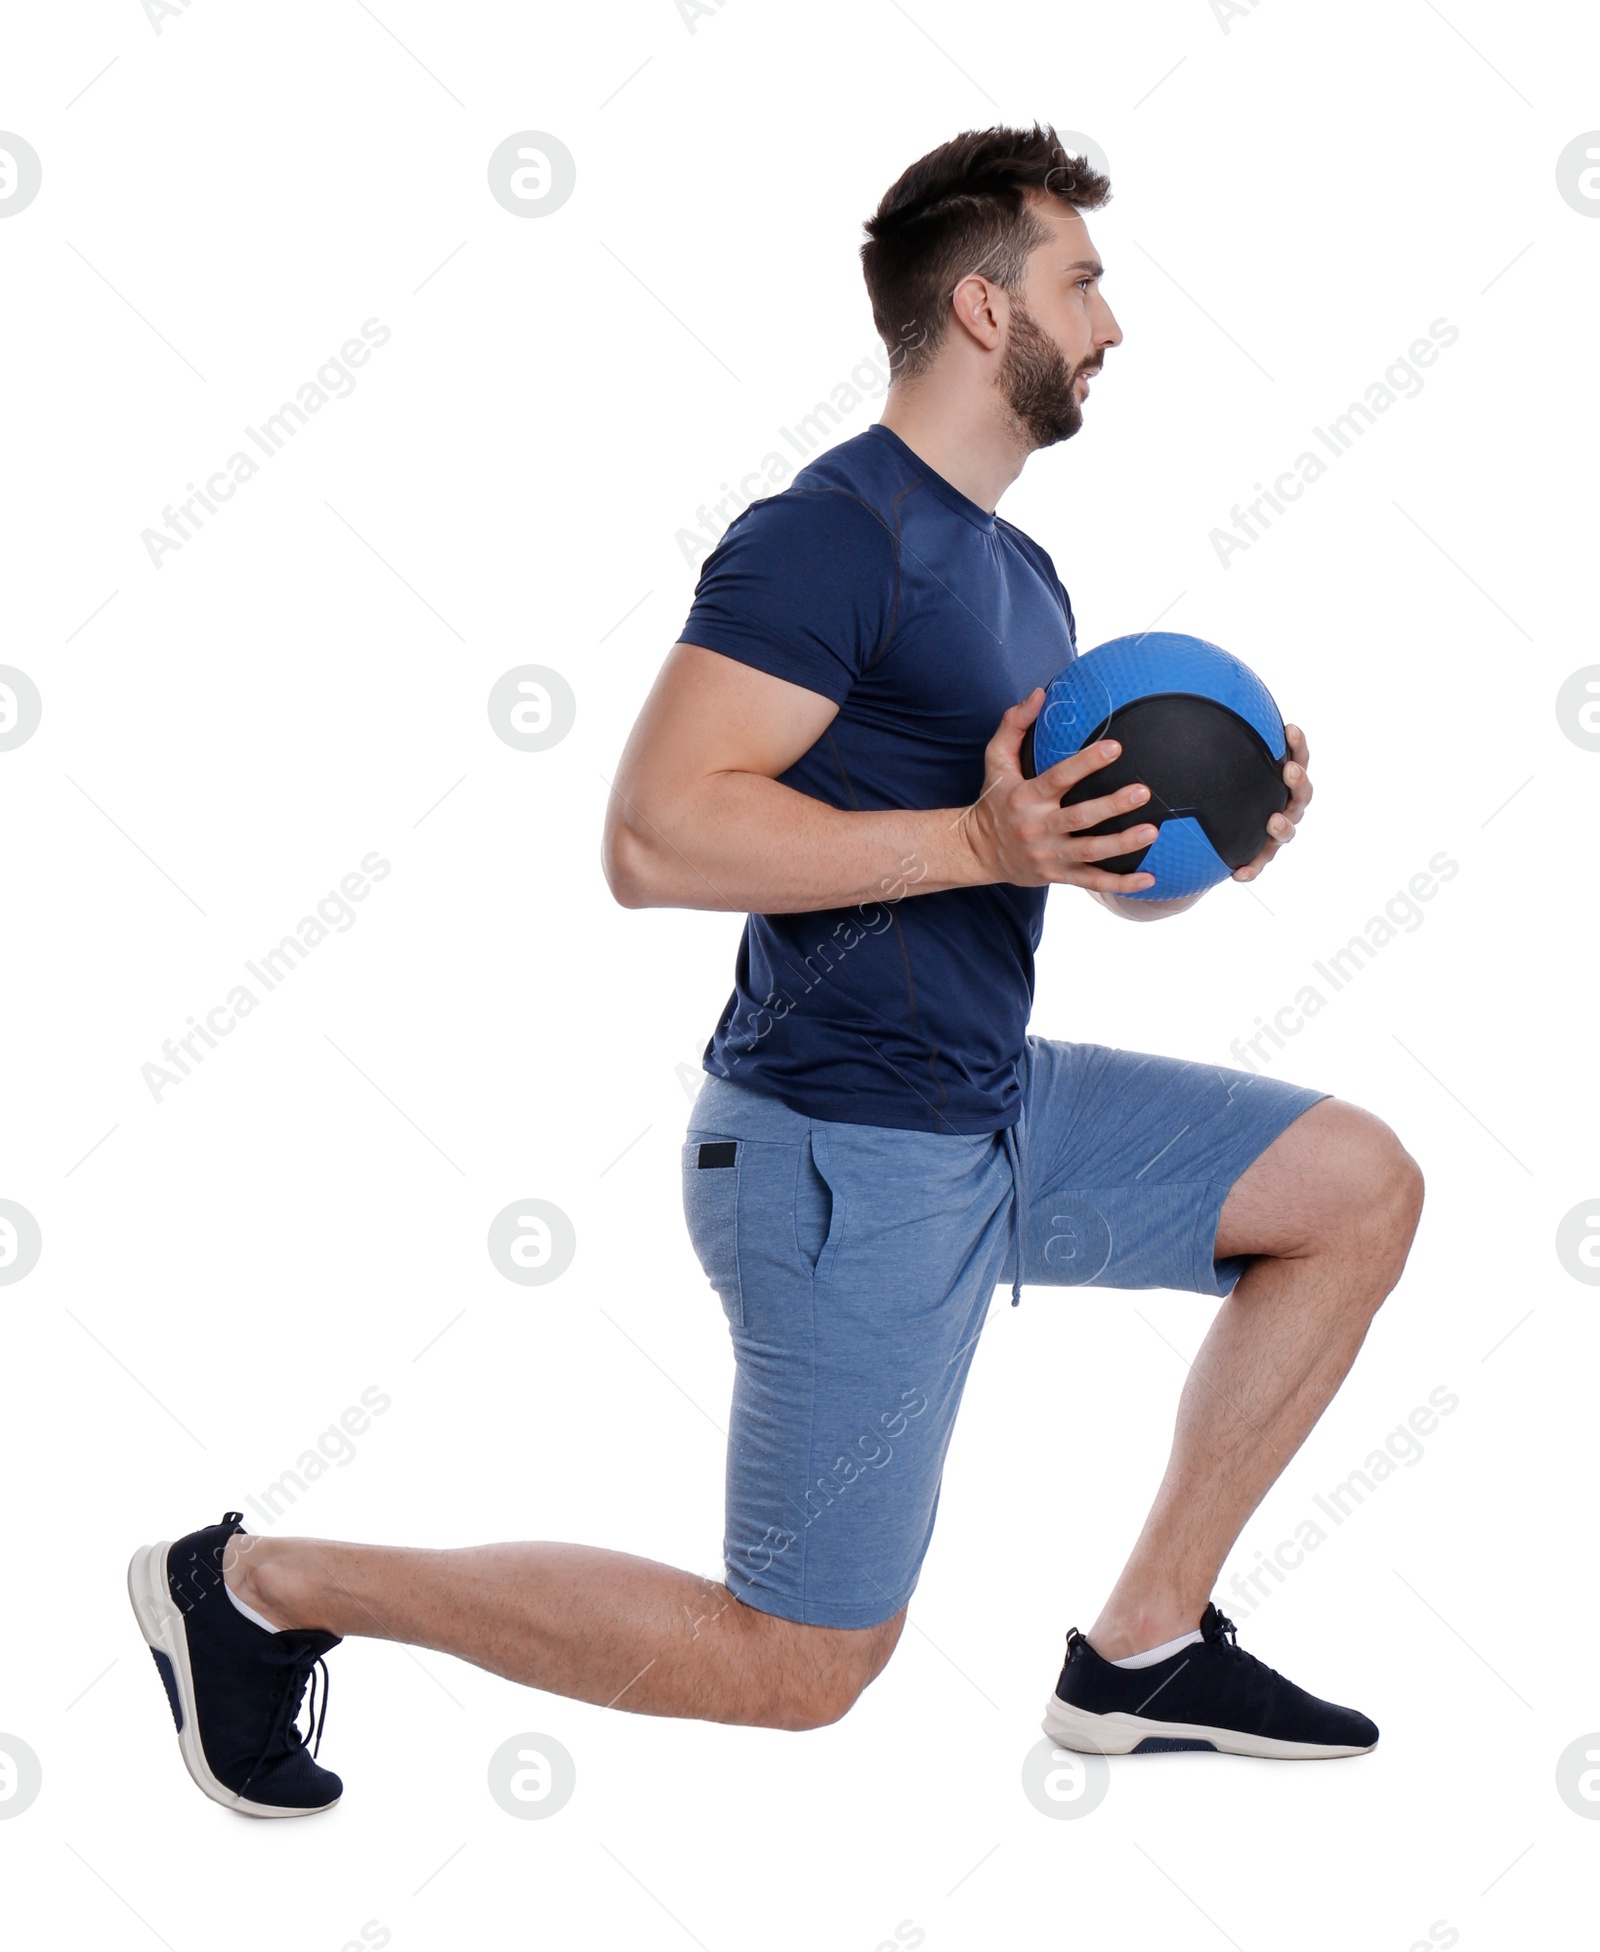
[683,1038,1327,1628]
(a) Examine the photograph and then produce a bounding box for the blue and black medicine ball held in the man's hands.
[1022,630,1290,902]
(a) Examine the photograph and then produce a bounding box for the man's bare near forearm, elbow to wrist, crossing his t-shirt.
[605,773,991,915]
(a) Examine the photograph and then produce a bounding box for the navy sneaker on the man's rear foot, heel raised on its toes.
[127,1511,343,1817]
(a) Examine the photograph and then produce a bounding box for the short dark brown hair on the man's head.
[860,123,1110,379]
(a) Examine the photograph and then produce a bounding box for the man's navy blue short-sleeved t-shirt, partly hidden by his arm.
[681,426,1077,1132]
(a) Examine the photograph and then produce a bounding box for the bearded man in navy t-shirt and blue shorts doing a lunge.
[129,127,1422,1815]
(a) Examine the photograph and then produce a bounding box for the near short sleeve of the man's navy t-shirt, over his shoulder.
[679,488,898,705]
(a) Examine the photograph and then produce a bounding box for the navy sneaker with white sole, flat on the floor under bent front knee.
[1044,1603,1378,1761]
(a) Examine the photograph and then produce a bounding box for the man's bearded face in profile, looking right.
[997,199,1122,447]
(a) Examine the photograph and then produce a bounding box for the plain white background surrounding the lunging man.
[0,0,1600,1952]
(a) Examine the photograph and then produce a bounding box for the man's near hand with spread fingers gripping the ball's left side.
[948,685,1159,894]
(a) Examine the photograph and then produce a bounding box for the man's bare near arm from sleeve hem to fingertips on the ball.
[603,644,1153,915]
